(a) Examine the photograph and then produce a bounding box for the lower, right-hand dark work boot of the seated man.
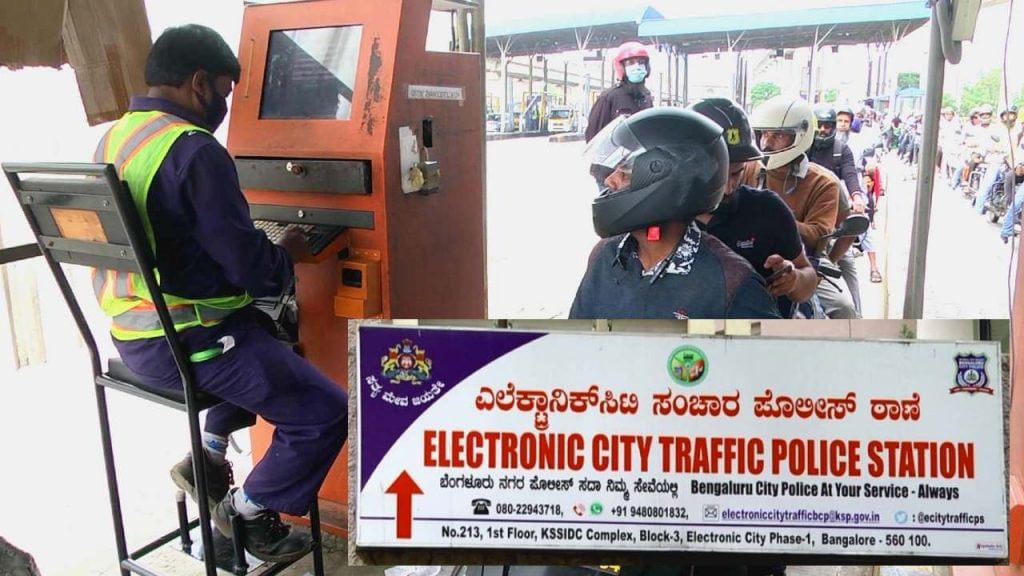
[213,488,312,562]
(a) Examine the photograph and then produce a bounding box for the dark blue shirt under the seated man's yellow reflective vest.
[114,96,293,381]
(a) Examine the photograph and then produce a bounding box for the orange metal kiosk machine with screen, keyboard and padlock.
[227,0,486,531]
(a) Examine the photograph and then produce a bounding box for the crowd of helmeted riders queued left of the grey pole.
[569,42,902,319]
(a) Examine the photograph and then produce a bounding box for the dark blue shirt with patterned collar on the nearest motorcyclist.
[569,224,779,319]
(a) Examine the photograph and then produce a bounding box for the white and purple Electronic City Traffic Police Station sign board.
[355,326,1008,559]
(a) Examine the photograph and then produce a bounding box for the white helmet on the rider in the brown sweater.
[751,96,818,170]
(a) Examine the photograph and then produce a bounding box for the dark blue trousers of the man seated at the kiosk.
[184,328,348,516]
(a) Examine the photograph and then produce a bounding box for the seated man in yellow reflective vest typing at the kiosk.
[93,25,348,562]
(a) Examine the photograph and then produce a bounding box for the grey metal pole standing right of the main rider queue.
[903,16,946,319]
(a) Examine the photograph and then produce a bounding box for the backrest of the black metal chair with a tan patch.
[0,163,190,378]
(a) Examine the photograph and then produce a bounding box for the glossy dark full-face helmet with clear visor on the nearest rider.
[586,108,729,238]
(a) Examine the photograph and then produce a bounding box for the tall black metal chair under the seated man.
[2,163,324,576]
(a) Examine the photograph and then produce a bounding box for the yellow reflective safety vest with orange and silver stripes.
[92,111,252,340]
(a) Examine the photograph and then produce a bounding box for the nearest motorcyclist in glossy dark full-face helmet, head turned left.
[569,108,778,319]
